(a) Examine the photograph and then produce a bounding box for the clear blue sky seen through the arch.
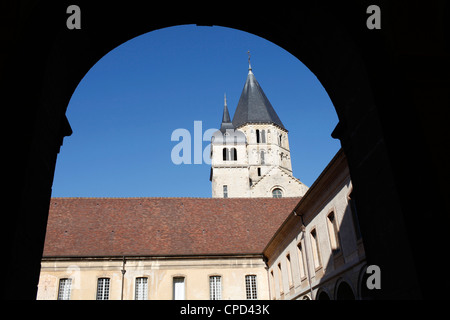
[52,25,340,197]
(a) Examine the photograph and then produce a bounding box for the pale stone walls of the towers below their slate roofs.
[211,124,308,198]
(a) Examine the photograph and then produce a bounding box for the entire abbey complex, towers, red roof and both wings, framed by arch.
[37,63,370,300]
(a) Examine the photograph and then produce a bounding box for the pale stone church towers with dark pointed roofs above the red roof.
[211,67,308,198]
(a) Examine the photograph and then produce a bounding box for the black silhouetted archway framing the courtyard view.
[0,0,450,299]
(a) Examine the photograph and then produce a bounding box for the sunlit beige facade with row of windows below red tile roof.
[37,255,269,300]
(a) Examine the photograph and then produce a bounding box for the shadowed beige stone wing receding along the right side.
[264,151,366,299]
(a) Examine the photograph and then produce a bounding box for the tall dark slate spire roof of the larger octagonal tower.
[233,67,286,130]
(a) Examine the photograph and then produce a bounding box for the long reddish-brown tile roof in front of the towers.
[44,198,300,257]
